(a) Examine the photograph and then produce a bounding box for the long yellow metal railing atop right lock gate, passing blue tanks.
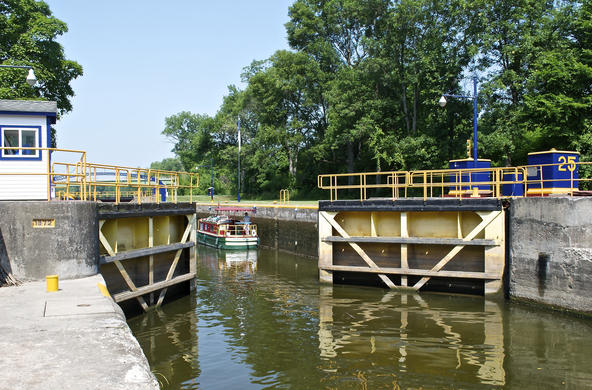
[317,162,592,201]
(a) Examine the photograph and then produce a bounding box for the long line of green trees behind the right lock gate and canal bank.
[152,0,592,198]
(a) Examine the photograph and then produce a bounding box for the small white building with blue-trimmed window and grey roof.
[0,100,57,200]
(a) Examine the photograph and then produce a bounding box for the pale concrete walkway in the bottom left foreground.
[0,275,159,389]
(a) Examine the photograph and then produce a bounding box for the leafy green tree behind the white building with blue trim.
[0,0,82,114]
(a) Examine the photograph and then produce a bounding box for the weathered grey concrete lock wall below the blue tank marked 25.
[508,197,592,314]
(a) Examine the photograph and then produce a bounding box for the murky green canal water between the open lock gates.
[128,247,592,389]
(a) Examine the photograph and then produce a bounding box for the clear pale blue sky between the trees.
[45,0,292,168]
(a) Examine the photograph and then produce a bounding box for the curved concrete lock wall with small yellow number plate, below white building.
[0,201,99,281]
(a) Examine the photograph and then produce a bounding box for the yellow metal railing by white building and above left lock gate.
[0,147,199,203]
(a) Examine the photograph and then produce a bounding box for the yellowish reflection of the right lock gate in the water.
[319,286,505,387]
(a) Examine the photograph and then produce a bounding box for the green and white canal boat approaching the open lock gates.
[197,215,259,249]
